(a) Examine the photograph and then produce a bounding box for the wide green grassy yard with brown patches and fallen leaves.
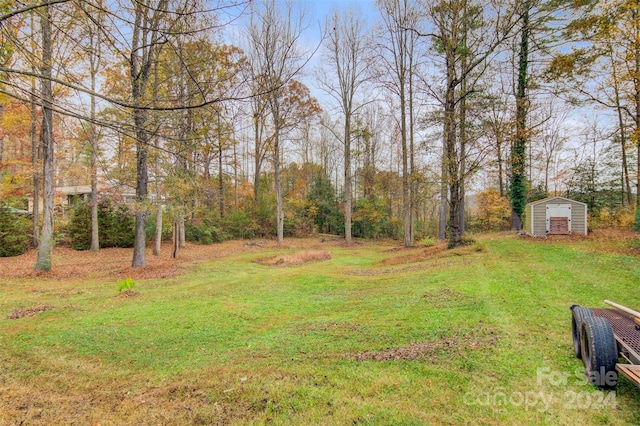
[0,233,640,425]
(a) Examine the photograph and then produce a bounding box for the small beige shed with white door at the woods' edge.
[524,197,587,236]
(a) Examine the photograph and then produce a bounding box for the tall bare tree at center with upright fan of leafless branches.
[320,9,369,243]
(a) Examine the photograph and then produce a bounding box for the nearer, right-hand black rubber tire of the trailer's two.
[580,316,618,389]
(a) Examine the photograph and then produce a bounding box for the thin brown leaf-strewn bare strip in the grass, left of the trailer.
[344,333,498,361]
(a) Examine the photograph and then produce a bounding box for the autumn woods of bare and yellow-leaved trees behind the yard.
[0,0,640,270]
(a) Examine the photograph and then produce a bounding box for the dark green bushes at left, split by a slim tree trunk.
[68,200,135,250]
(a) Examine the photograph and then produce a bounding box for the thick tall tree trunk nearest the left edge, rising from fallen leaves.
[34,6,54,271]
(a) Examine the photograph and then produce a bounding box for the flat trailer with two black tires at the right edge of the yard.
[571,300,640,389]
